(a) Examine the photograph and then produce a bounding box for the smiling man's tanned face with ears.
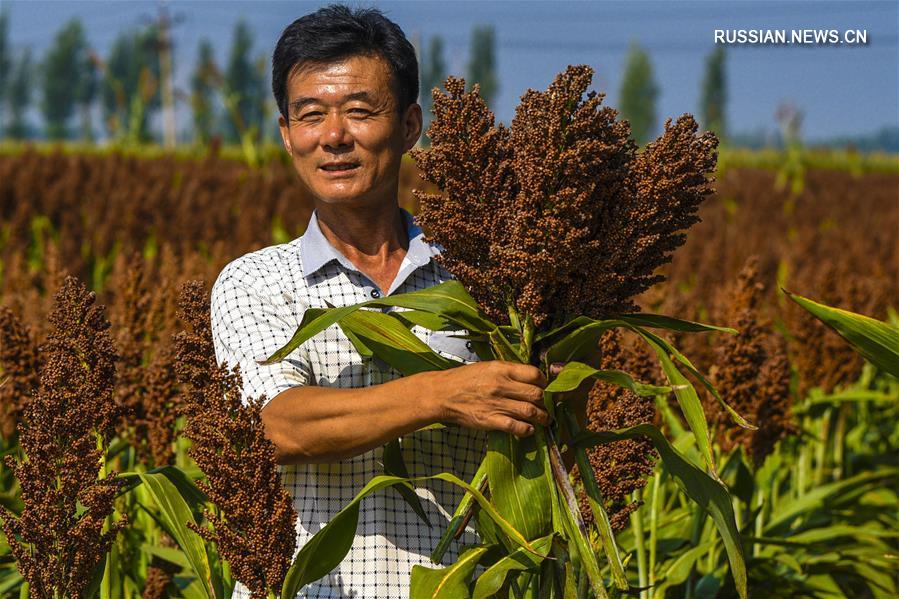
[279,56,422,206]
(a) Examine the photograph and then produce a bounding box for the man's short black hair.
[272,4,418,119]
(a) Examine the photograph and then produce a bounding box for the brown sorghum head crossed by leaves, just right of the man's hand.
[581,331,661,530]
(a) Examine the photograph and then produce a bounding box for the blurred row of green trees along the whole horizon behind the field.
[0,7,727,146]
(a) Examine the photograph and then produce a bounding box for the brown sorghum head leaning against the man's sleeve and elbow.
[176,281,297,599]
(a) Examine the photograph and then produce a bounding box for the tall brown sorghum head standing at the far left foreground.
[3,277,125,597]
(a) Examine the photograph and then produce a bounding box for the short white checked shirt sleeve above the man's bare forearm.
[210,263,312,403]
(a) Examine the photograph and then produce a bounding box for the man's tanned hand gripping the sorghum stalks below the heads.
[429,360,549,437]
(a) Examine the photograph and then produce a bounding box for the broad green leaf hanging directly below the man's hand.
[485,429,552,539]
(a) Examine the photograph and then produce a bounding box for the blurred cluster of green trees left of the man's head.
[0,11,274,145]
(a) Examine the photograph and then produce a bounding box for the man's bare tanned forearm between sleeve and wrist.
[262,373,440,464]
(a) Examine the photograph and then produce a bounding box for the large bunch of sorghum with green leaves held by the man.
[270,66,746,597]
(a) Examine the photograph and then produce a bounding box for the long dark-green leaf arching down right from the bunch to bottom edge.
[573,424,747,599]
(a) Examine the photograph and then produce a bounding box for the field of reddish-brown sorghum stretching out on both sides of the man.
[0,139,899,599]
